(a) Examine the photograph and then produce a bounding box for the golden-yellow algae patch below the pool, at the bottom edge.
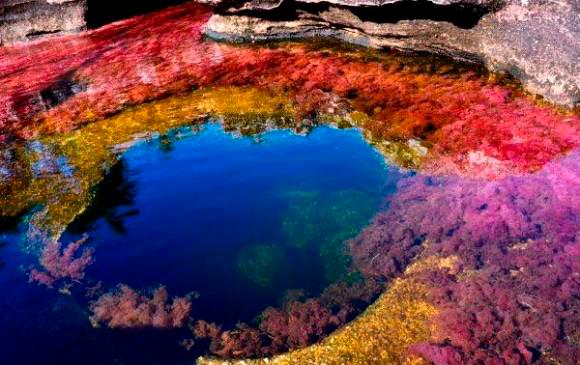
[197,278,436,365]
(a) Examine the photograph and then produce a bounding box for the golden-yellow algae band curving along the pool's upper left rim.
[0,87,292,242]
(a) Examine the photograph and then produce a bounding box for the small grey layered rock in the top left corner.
[0,0,86,45]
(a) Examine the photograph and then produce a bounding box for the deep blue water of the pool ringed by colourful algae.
[0,124,399,364]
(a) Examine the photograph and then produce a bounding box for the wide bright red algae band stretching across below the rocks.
[0,3,580,178]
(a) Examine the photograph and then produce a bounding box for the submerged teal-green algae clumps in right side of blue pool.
[238,190,379,289]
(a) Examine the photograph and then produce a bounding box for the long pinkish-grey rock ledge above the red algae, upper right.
[200,0,580,107]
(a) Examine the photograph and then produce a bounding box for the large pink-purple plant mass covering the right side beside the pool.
[350,152,580,364]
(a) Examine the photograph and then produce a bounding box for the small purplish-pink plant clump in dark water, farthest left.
[28,236,94,288]
